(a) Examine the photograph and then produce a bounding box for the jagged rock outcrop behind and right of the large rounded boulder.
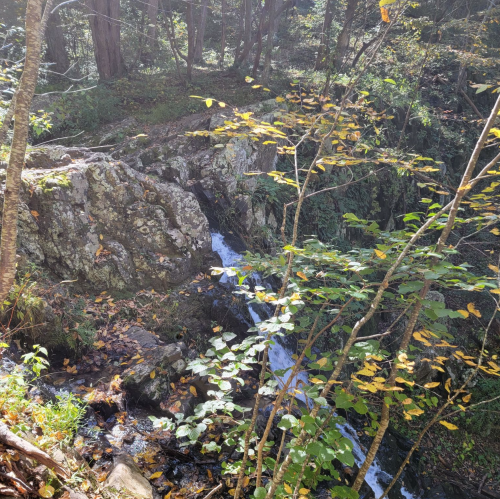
[112,99,279,236]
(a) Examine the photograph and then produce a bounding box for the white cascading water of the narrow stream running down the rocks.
[212,232,415,499]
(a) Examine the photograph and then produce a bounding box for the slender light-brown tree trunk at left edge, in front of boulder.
[0,0,42,304]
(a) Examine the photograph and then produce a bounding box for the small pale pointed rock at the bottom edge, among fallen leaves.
[104,454,155,499]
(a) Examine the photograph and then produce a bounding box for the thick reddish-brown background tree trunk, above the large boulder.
[85,0,125,80]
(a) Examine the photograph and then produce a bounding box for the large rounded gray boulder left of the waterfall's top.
[0,148,211,291]
